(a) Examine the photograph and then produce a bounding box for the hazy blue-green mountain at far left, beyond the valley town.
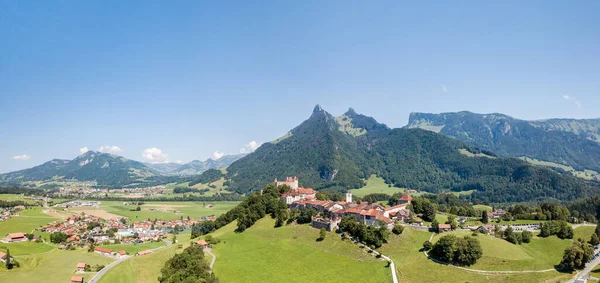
[0,151,160,189]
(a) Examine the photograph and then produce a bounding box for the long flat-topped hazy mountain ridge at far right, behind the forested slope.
[407,111,600,175]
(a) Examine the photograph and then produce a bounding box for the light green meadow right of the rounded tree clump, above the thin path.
[432,229,577,271]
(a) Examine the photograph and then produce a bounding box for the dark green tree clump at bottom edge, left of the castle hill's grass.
[158,245,218,283]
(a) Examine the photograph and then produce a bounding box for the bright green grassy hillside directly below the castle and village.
[213,218,391,282]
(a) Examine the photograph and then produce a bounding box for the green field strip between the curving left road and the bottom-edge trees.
[99,234,192,283]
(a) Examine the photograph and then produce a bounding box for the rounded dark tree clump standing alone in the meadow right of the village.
[432,235,483,266]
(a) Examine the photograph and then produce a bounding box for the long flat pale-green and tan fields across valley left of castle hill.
[70,201,239,221]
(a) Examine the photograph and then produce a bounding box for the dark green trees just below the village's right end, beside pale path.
[339,215,390,248]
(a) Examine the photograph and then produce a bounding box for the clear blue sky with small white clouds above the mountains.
[0,0,600,172]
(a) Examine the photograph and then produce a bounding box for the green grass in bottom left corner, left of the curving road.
[0,250,113,283]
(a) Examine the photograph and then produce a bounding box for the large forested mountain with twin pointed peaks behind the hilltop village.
[203,106,600,202]
